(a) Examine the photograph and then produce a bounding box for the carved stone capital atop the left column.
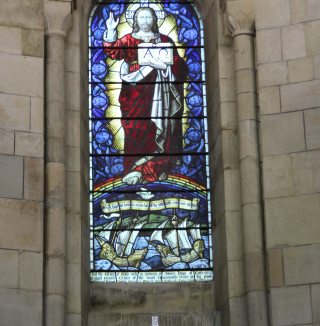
[44,0,72,36]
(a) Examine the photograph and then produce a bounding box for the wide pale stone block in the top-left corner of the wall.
[0,0,44,29]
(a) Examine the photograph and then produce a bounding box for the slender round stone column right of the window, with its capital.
[225,0,269,326]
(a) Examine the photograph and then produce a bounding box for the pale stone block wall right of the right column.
[256,0,320,326]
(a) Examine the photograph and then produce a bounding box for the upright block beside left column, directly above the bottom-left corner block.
[19,251,43,291]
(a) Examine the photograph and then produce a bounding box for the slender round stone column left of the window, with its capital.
[44,1,71,326]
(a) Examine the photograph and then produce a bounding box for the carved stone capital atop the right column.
[223,0,255,38]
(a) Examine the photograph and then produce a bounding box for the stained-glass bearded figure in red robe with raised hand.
[103,7,187,185]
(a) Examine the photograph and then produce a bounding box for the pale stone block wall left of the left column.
[0,0,44,325]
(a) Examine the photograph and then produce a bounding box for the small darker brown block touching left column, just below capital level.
[22,29,44,58]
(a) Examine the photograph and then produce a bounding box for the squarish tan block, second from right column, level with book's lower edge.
[288,57,314,83]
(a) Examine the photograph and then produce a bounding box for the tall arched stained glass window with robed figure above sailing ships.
[89,0,213,282]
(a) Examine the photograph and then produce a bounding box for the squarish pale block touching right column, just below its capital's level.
[257,28,282,63]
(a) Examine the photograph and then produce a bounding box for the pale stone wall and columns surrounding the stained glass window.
[0,0,320,326]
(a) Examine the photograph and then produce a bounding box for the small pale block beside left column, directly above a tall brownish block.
[15,132,44,157]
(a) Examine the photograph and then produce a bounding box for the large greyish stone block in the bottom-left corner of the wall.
[0,289,42,326]
